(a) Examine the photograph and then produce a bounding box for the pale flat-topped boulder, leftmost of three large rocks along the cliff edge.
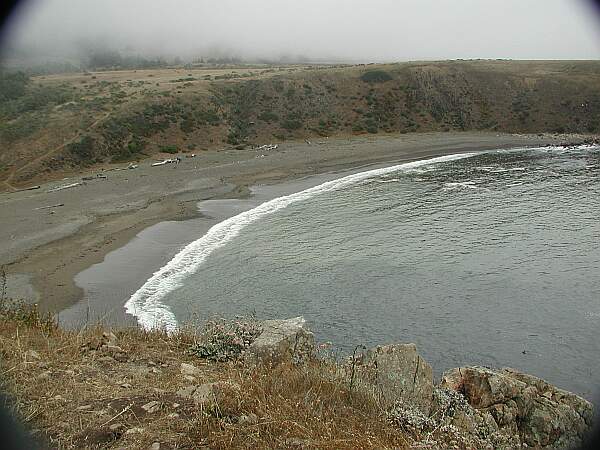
[246,317,315,365]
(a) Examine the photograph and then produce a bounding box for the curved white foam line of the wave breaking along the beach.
[125,153,477,332]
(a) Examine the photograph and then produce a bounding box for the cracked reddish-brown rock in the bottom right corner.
[441,367,593,449]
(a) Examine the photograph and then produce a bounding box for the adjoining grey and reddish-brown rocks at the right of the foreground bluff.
[349,344,593,450]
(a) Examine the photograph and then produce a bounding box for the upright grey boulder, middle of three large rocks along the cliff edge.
[356,344,433,415]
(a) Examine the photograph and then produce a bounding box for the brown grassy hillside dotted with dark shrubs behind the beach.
[0,61,600,187]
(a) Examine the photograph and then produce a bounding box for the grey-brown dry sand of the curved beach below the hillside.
[0,132,582,322]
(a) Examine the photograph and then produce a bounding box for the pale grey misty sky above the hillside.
[5,0,600,61]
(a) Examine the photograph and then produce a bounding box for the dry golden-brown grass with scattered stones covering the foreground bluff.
[0,309,408,449]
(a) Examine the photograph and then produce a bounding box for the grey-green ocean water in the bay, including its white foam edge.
[126,146,600,397]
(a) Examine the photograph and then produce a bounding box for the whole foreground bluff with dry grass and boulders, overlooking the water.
[0,306,593,449]
